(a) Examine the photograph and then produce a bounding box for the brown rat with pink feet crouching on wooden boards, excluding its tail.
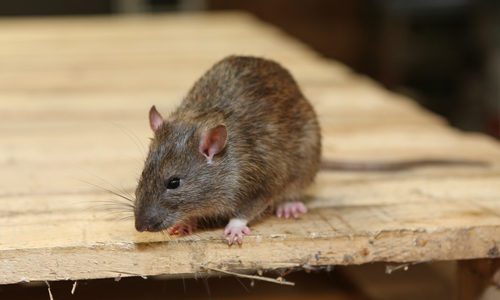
[134,56,321,245]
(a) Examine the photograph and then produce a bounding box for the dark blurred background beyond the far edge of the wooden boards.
[0,0,500,138]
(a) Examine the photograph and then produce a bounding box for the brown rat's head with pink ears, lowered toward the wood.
[134,106,227,231]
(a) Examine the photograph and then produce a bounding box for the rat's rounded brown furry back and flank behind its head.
[177,56,321,210]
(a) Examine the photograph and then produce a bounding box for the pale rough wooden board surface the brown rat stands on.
[0,13,500,283]
